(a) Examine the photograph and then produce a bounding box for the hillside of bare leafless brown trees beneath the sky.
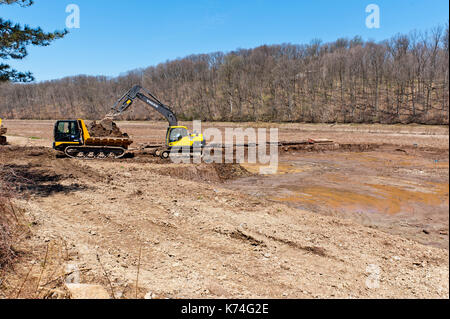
[0,24,449,124]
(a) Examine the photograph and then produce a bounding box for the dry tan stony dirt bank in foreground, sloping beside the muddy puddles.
[0,147,449,298]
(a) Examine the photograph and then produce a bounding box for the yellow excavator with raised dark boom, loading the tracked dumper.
[107,85,205,159]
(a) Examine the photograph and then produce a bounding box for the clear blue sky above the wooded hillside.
[0,0,449,81]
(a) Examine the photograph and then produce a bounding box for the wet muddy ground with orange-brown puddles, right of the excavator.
[227,146,449,249]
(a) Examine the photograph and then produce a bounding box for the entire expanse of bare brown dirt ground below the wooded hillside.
[0,121,449,298]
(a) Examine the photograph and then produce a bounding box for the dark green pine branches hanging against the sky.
[0,0,68,82]
